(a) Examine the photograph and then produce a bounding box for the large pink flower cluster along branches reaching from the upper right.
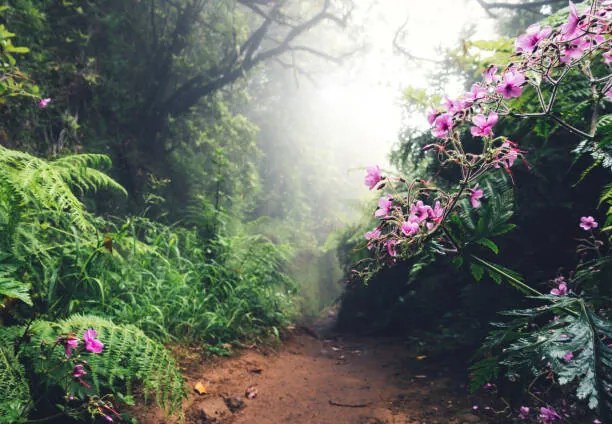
[364,0,612,264]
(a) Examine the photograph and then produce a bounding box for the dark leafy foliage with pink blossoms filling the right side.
[345,1,612,418]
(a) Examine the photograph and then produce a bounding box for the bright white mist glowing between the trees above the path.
[241,0,495,313]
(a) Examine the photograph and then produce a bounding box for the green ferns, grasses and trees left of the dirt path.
[0,0,338,423]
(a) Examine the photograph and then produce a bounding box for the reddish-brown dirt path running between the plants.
[139,331,487,424]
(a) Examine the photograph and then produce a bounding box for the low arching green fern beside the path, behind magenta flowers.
[23,315,186,414]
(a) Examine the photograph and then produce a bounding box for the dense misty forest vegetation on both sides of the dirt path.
[0,0,612,423]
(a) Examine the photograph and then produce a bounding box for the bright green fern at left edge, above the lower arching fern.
[0,146,125,306]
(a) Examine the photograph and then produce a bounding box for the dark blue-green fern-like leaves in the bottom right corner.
[471,295,612,416]
